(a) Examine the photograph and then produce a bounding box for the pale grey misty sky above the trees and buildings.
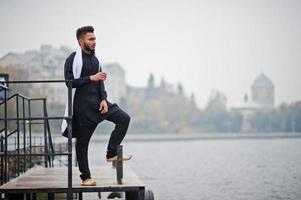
[0,0,301,107]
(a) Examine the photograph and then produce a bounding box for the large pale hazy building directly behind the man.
[0,45,127,104]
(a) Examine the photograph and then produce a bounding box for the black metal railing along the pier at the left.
[0,80,72,200]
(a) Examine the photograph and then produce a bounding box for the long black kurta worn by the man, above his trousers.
[65,51,118,136]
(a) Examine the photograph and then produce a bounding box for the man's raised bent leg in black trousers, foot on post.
[105,108,131,158]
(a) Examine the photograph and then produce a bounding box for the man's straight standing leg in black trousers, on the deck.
[76,125,96,180]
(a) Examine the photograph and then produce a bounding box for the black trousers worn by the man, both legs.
[75,108,130,180]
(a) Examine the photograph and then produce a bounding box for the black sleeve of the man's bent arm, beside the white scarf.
[64,53,90,88]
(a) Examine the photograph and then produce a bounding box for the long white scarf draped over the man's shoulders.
[61,48,100,133]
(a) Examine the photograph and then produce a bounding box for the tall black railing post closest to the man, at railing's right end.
[67,82,73,200]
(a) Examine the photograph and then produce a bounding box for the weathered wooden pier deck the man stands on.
[0,166,145,193]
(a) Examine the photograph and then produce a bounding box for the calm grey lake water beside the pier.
[85,138,301,200]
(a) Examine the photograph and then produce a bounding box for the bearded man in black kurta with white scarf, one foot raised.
[62,26,132,186]
